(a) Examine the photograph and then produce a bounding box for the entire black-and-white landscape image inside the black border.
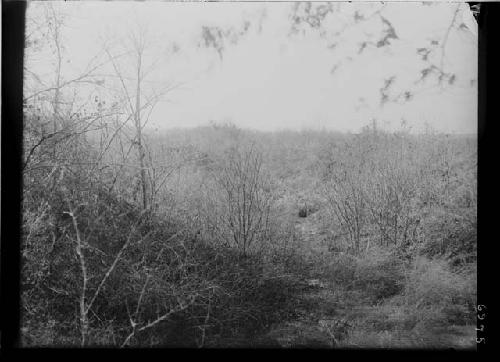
[20,1,481,349]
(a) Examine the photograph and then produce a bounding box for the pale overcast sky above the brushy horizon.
[28,1,477,133]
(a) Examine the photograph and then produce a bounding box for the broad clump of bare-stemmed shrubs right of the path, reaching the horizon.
[321,127,476,257]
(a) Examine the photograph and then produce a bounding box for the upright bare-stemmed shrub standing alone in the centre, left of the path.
[199,146,273,255]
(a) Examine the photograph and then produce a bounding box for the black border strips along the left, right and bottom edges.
[0,0,492,357]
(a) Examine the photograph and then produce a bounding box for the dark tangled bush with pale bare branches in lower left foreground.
[22,162,211,345]
